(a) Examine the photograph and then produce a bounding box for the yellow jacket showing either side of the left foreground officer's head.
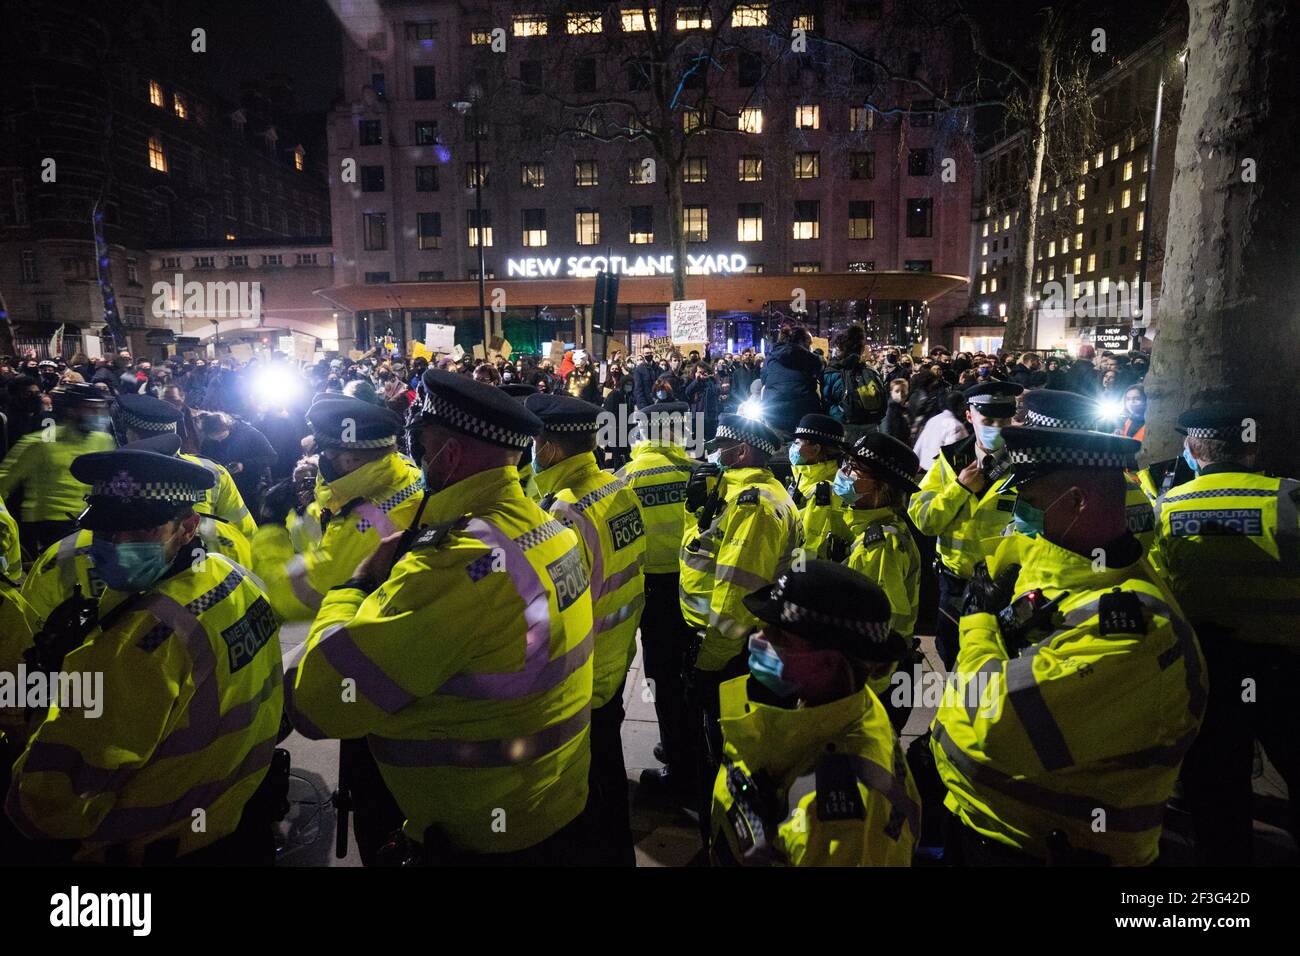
[22,515,260,631]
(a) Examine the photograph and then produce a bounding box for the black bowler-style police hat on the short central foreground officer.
[744,561,906,661]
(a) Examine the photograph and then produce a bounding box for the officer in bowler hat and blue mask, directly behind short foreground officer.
[835,432,920,731]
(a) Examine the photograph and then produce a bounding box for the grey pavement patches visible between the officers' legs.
[271,624,1297,866]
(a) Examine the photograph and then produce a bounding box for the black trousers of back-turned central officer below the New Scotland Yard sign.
[641,574,698,787]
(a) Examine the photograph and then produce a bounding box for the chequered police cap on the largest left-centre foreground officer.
[411,368,542,449]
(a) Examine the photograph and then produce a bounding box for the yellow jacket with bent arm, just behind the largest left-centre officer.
[252,451,423,620]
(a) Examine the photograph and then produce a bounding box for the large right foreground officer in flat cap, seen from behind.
[931,427,1206,866]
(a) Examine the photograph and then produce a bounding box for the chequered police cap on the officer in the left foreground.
[72,449,216,531]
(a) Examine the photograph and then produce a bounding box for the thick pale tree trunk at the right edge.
[1145,0,1300,475]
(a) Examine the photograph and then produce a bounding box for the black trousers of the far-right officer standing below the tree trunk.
[1183,639,1300,866]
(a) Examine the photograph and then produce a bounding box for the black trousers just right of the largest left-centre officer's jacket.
[584,684,637,866]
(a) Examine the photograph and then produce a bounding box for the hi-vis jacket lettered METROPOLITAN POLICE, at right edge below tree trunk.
[1152,464,1300,652]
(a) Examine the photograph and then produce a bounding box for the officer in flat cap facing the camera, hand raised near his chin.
[907,381,1024,670]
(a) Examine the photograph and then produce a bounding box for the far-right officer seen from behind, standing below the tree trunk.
[1153,403,1300,866]
